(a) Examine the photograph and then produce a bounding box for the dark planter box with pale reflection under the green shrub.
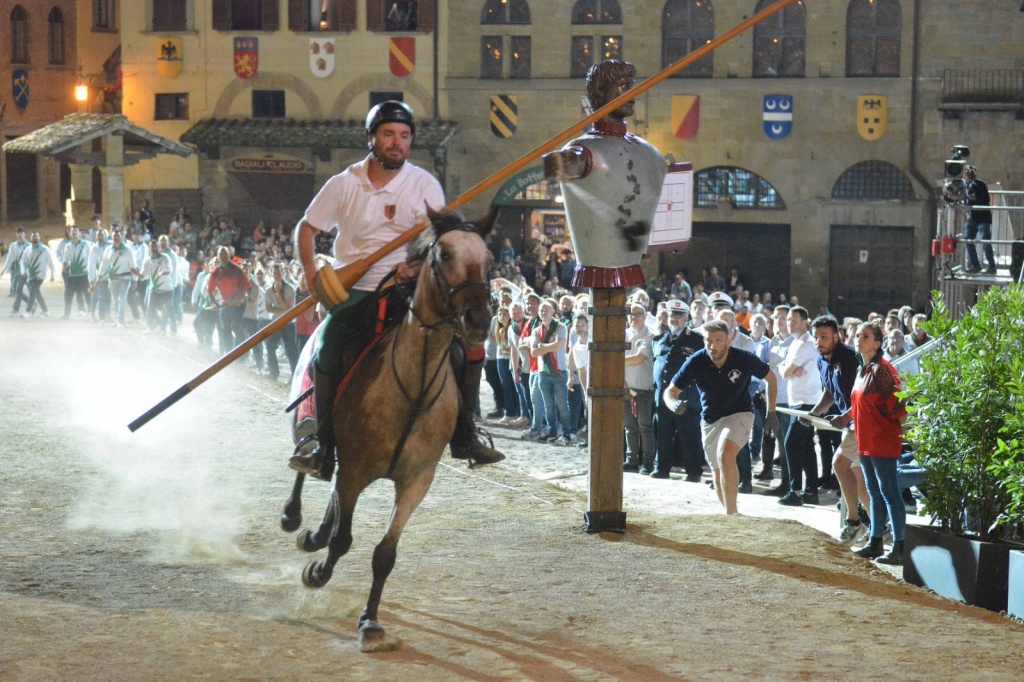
[903,524,1020,611]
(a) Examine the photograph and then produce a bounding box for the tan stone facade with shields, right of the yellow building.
[444,0,1024,314]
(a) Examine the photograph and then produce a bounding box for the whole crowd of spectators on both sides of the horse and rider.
[3,209,929,522]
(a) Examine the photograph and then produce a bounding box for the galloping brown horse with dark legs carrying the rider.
[282,213,492,651]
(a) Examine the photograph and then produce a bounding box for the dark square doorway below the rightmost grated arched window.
[828,225,913,319]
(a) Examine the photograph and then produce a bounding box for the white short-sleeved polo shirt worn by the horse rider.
[303,156,444,291]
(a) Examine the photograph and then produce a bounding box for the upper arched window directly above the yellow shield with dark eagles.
[846,0,900,76]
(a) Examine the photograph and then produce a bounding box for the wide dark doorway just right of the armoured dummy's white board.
[660,222,799,299]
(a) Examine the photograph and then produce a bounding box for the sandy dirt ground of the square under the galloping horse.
[0,279,1024,681]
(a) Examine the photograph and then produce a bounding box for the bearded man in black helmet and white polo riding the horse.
[289,100,505,480]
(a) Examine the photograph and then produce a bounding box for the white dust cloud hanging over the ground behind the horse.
[18,328,253,562]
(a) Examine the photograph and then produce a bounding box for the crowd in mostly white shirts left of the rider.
[3,202,333,380]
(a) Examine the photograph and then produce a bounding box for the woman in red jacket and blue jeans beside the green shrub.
[851,323,906,565]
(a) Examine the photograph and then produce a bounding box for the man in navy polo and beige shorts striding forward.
[664,319,778,514]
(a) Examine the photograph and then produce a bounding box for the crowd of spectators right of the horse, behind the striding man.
[475,231,930,539]
